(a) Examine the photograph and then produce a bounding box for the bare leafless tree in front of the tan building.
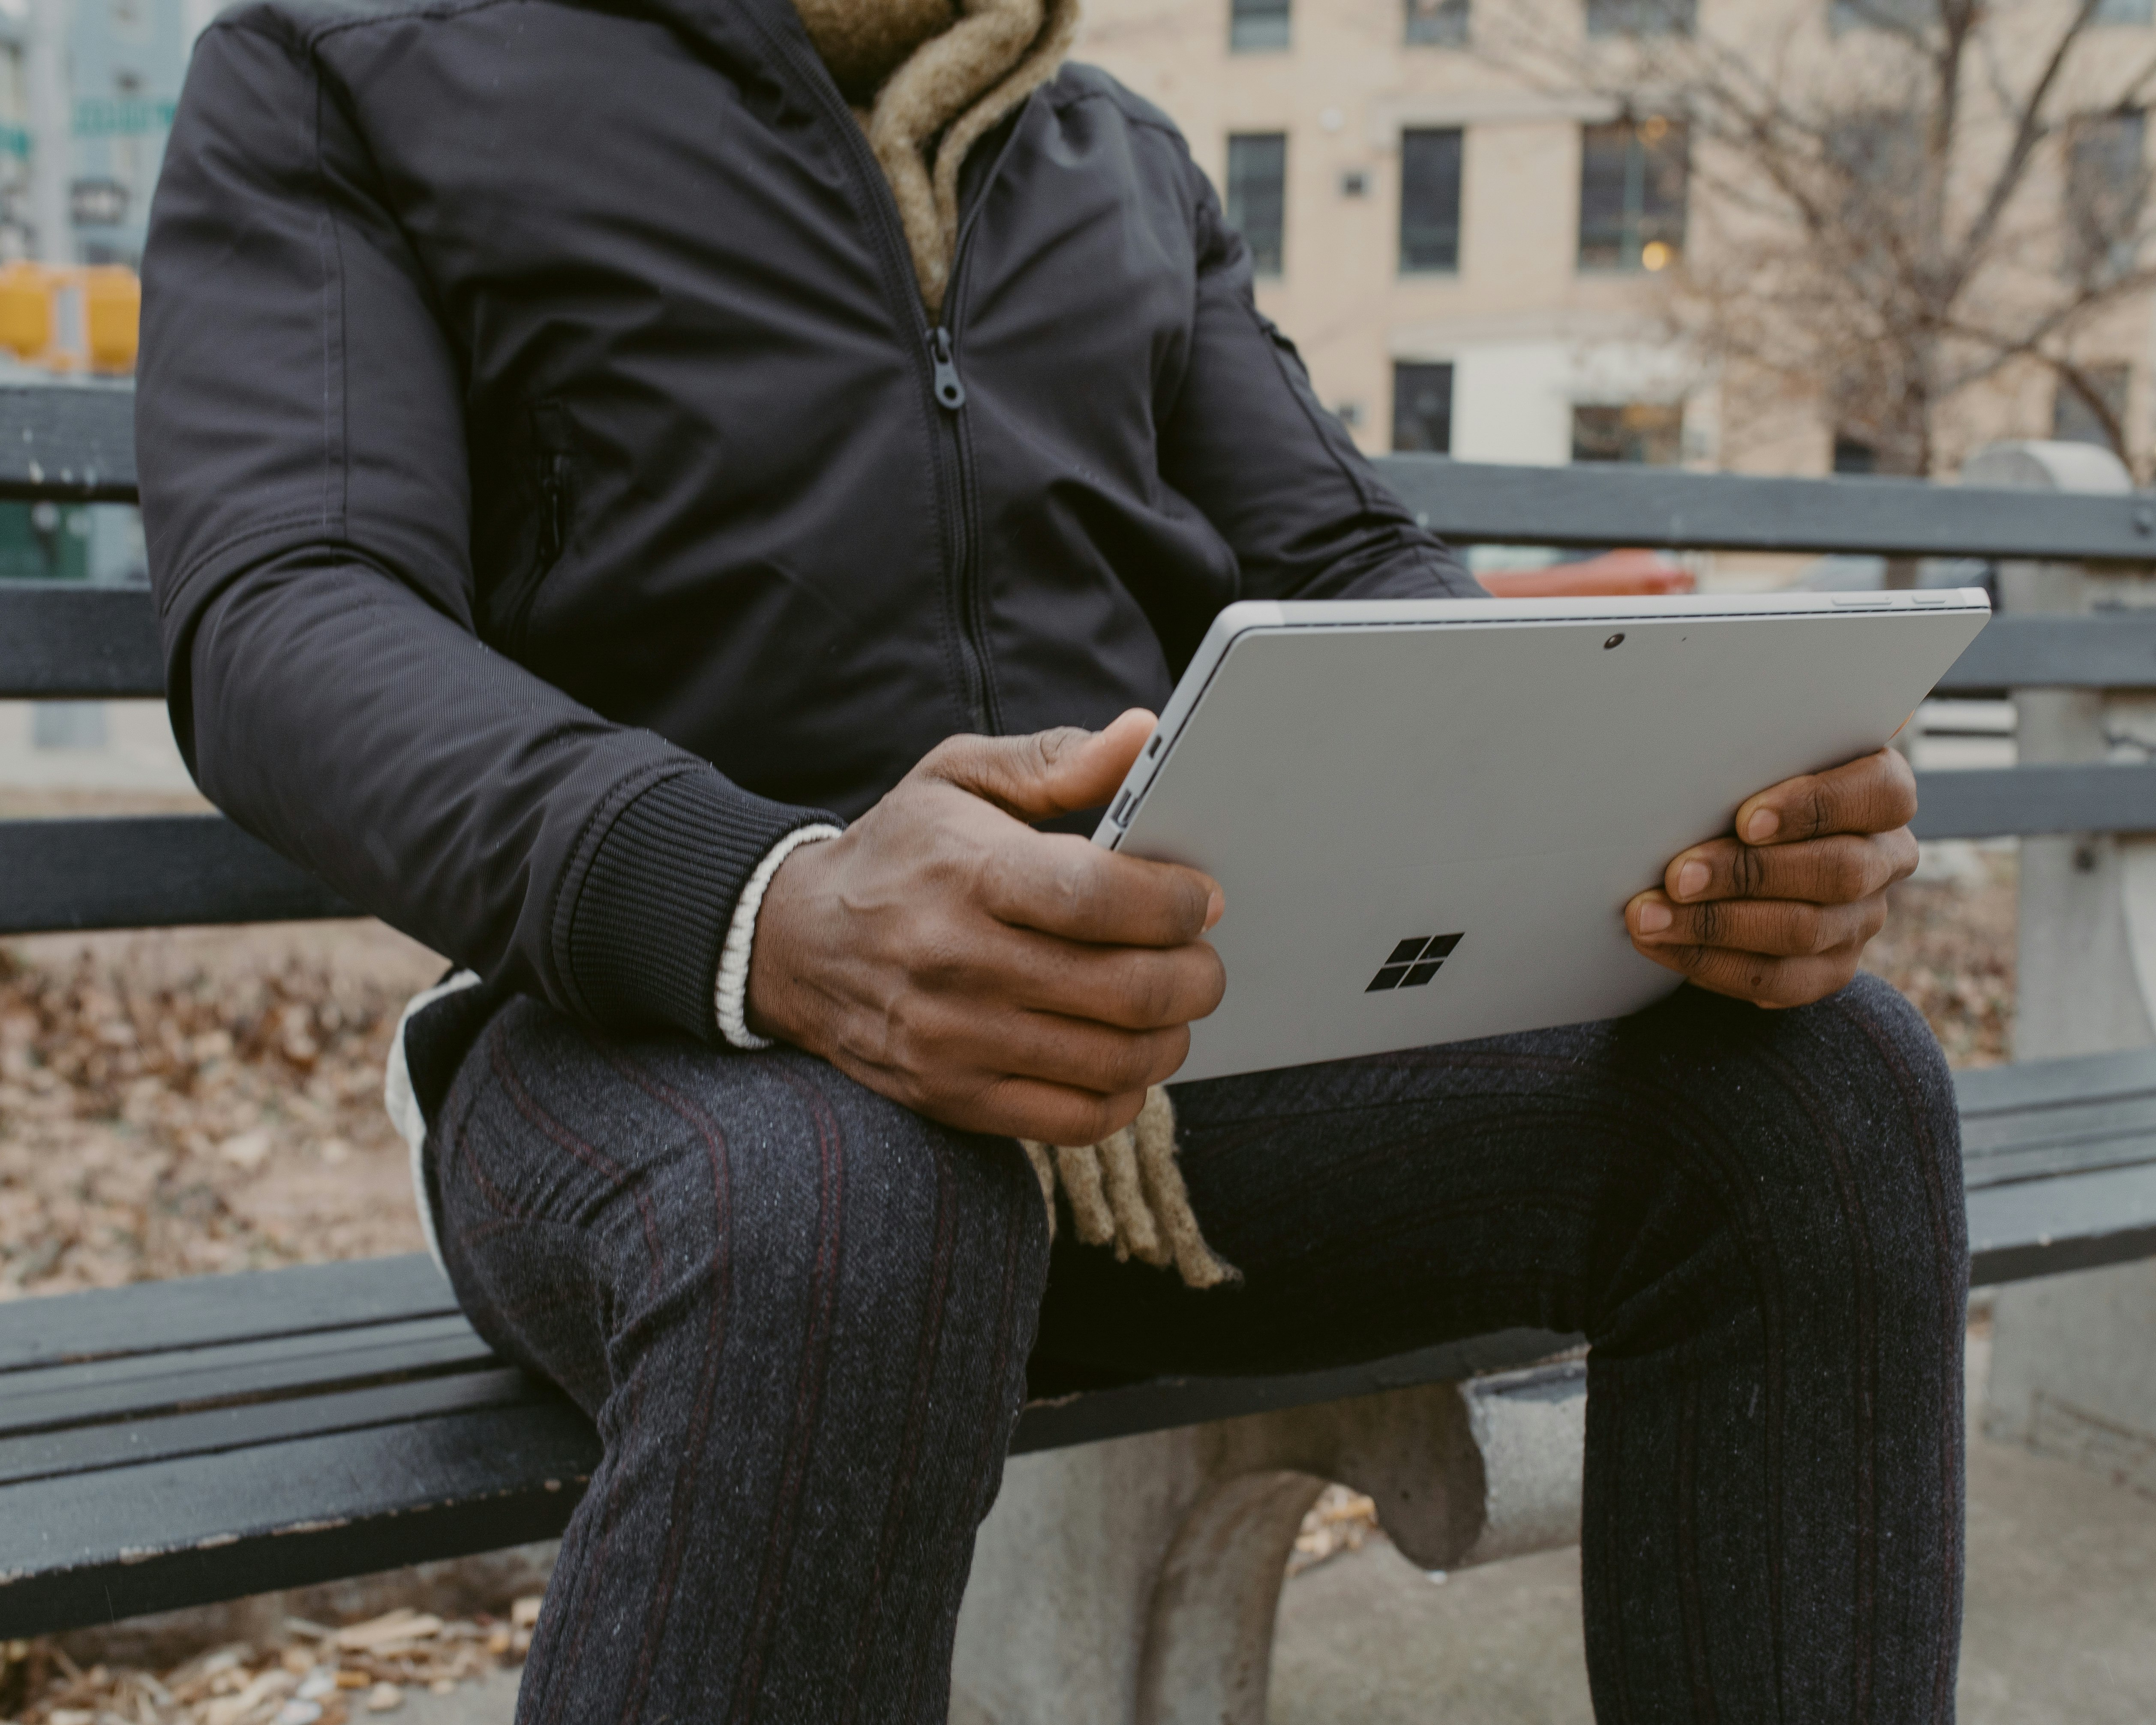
[1479,0,2156,472]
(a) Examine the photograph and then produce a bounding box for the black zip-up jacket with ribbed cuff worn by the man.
[136,0,1475,1037]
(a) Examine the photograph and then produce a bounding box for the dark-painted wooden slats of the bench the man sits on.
[0,377,2156,1716]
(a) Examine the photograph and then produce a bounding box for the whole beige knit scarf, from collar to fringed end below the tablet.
[793,0,1237,1287]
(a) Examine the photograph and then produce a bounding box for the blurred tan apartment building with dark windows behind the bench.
[1078,0,2156,472]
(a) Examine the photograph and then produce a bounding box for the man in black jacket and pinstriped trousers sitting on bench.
[138,0,1966,1725]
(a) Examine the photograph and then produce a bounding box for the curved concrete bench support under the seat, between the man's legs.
[951,1361,1587,1725]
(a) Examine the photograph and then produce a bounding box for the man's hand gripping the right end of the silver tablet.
[1624,748,1917,1007]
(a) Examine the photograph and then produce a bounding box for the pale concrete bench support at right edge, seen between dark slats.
[1962,442,2156,1494]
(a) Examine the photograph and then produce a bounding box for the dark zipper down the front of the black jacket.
[750,9,1015,735]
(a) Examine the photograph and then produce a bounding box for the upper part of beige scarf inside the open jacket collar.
[793,0,1078,317]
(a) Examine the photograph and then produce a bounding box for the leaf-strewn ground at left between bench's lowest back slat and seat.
[0,923,442,1298]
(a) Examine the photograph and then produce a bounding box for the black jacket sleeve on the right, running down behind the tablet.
[1160,149,1488,599]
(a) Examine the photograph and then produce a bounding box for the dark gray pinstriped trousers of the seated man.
[429,977,1966,1725]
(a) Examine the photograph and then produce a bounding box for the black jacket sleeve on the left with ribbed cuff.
[136,11,832,1039]
